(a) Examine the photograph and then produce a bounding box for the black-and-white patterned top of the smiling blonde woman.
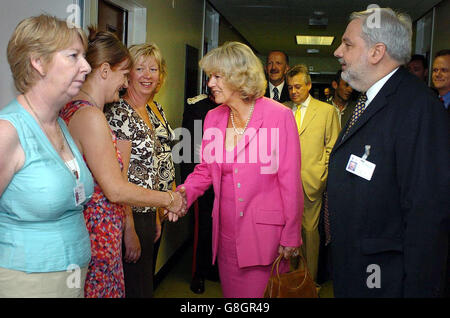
[105,99,175,213]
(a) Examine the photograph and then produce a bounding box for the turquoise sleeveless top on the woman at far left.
[0,99,94,273]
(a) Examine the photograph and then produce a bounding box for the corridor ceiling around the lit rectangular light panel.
[208,0,441,57]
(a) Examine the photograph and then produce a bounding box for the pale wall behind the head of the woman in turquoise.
[0,0,73,108]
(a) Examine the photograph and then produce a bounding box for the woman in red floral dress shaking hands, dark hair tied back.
[61,29,183,297]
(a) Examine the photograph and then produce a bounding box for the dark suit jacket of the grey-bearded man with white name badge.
[327,67,450,297]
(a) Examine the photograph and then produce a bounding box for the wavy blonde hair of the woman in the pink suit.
[199,42,267,101]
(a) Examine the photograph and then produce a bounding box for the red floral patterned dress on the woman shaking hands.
[60,100,125,298]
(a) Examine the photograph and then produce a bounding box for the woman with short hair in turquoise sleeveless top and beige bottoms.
[0,15,93,297]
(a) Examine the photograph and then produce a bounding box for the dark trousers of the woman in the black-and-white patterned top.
[123,212,156,298]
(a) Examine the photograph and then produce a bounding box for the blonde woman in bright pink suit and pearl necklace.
[178,42,303,298]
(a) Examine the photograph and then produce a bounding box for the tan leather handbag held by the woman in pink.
[264,254,318,298]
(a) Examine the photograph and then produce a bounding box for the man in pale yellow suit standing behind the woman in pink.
[285,65,340,280]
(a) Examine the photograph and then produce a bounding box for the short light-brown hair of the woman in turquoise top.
[7,14,88,93]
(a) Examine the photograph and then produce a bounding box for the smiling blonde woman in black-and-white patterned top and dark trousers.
[106,43,175,297]
